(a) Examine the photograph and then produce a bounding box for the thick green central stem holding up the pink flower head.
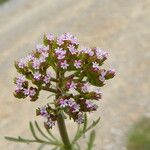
[56,70,72,150]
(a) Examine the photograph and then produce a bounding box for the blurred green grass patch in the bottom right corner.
[127,118,150,150]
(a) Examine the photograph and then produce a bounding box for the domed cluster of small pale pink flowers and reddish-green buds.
[14,33,115,128]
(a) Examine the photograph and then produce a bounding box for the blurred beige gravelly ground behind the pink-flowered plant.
[0,0,150,150]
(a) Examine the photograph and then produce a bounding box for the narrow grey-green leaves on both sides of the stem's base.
[5,114,100,150]
